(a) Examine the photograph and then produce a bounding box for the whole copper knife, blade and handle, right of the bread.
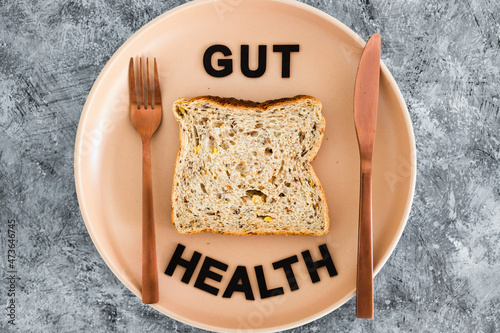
[354,33,381,318]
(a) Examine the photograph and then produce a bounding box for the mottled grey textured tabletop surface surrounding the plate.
[0,0,500,332]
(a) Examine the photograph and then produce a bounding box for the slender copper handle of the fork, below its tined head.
[142,138,159,304]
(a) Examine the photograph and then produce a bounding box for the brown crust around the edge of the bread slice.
[171,95,330,236]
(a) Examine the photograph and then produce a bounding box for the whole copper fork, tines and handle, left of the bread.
[129,58,162,304]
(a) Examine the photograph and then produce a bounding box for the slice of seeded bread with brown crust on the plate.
[172,96,329,236]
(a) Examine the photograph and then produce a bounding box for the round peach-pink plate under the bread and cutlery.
[75,0,416,331]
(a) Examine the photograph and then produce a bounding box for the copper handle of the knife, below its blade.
[356,166,373,318]
